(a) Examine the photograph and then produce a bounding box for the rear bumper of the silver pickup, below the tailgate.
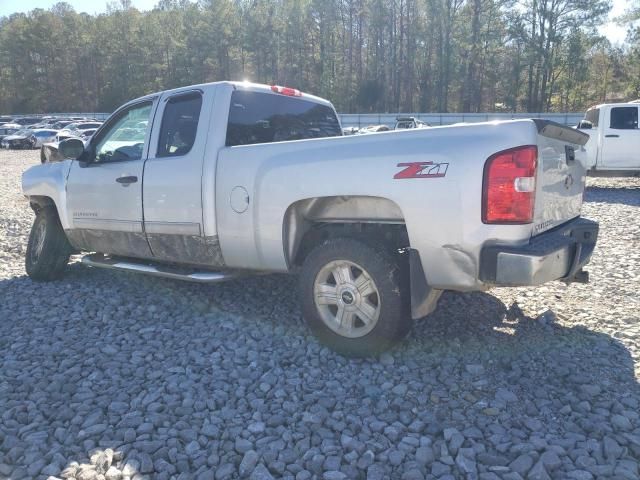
[480,218,598,287]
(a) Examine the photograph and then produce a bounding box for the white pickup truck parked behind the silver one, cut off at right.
[578,101,640,176]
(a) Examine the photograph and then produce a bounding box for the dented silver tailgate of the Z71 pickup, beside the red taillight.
[532,120,589,236]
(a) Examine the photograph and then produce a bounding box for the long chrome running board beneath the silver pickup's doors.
[82,253,241,283]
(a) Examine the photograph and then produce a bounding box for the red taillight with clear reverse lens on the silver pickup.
[482,145,538,224]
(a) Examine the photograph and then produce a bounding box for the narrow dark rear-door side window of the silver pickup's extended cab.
[157,92,202,157]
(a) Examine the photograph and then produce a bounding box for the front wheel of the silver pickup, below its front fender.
[25,207,72,282]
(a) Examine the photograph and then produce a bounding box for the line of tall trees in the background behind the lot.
[0,0,640,113]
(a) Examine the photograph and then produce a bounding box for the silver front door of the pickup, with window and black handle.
[67,99,157,258]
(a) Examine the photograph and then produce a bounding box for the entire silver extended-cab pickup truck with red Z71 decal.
[22,82,598,356]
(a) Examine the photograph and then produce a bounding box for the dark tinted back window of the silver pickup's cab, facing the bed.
[226,90,342,147]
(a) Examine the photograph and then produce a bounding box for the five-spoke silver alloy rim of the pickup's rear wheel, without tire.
[313,260,380,338]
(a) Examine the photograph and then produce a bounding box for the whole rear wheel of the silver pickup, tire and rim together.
[300,238,412,357]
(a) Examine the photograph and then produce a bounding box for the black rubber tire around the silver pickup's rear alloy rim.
[300,238,413,357]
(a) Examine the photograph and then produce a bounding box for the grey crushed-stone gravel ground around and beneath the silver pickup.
[0,151,640,480]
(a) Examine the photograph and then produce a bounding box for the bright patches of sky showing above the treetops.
[0,0,630,44]
